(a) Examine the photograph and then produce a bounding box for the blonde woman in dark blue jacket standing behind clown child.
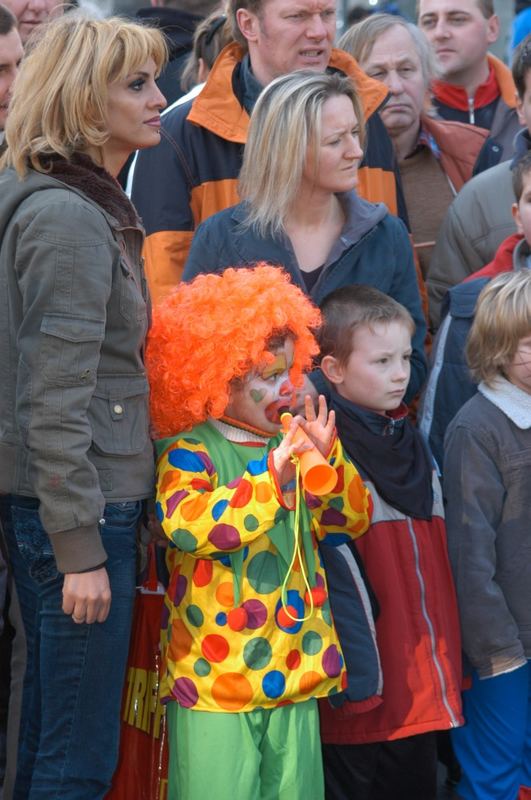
[183,70,426,399]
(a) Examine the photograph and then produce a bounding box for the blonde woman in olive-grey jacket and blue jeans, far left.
[0,15,166,800]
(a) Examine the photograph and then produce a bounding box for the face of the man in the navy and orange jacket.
[237,0,336,86]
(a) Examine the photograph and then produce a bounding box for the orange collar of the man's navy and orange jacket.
[187,42,388,144]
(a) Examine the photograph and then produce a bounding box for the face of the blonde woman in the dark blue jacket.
[301,94,363,194]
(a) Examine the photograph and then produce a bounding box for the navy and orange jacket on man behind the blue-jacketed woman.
[132,44,406,303]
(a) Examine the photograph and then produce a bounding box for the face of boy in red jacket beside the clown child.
[322,320,411,415]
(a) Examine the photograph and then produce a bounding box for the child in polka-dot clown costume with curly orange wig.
[147,265,370,800]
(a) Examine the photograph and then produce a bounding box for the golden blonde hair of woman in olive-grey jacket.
[2,14,167,175]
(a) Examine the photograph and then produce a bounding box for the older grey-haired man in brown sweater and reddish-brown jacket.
[338,14,487,288]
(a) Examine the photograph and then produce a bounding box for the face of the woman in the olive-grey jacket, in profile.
[102,58,167,174]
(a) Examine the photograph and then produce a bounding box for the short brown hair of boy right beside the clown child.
[317,285,415,364]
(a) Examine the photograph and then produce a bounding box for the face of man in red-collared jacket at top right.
[419,0,499,83]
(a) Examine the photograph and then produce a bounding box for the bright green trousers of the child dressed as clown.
[167,699,324,800]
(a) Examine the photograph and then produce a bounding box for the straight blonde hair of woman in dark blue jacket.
[239,70,364,236]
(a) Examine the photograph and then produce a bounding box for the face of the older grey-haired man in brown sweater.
[360,25,426,143]
